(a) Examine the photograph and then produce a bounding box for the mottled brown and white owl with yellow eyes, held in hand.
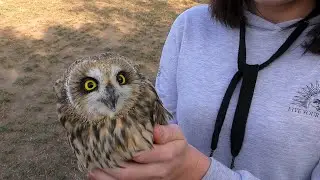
[55,54,171,171]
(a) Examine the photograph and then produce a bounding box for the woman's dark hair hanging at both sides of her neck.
[210,0,320,54]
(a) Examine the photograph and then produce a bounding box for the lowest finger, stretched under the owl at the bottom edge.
[103,162,168,180]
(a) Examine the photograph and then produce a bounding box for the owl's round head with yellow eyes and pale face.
[65,56,142,118]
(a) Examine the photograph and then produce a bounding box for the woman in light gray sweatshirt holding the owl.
[89,0,320,180]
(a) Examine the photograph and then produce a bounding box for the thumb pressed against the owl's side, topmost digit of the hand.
[153,124,185,144]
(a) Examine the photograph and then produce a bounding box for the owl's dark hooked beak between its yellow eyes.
[101,85,119,112]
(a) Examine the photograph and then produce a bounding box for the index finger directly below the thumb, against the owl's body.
[133,140,187,163]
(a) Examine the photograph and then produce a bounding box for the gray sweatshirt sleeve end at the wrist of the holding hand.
[202,157,259,180]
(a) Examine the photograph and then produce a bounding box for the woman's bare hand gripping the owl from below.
[88,124,210,180]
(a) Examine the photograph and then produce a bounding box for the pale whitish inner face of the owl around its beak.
[82,65,133,118]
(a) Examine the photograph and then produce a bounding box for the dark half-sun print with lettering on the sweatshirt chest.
[288,81,320,117]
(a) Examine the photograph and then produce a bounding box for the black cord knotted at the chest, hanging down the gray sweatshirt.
[210,8,319,169]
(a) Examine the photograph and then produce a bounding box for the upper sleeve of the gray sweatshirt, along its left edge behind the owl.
[155,14,183,124]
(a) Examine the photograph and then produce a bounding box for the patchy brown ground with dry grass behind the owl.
[0,0,205,180]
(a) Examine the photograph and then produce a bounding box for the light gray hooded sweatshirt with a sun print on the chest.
[156,5,320,180]
